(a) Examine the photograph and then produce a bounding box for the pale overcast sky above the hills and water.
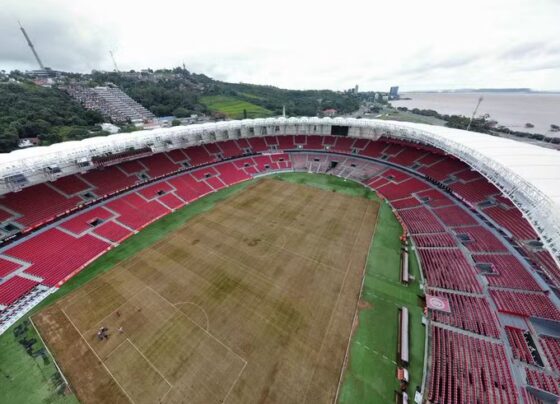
[0,0,560,91]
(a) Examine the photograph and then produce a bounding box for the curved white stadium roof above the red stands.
[0,117,560,256]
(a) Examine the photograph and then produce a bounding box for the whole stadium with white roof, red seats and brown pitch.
[0,118,560,404]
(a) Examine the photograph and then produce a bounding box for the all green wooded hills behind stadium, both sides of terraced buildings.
[0,68,360,153]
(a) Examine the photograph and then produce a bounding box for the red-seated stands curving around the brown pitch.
[0,135,560,403]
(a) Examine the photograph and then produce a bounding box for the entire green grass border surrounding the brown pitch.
[0,173,424,404]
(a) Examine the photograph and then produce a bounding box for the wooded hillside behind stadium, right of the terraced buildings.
[87,68,360,118]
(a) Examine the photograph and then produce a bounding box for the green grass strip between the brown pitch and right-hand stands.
[339,203,425,403]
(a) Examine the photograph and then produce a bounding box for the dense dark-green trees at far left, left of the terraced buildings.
[0,82,105,152]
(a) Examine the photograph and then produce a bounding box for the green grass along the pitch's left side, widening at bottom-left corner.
[0,181,251,404]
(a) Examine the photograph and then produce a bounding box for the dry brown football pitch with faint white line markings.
[33,179,378,403]
